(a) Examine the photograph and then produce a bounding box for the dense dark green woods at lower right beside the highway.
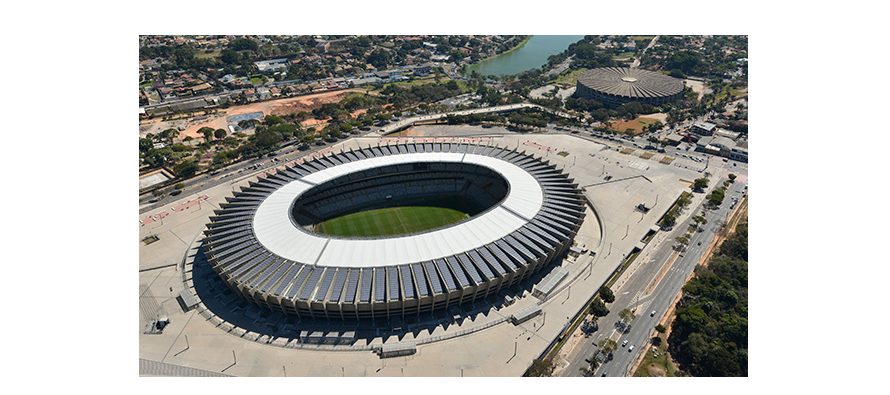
[668,221,748,377]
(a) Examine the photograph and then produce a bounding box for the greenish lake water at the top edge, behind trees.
[469,35,584,76]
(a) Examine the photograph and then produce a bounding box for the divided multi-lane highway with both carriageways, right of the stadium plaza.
[560,179,744,377]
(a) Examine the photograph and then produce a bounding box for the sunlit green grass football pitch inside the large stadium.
[315,206,467,237]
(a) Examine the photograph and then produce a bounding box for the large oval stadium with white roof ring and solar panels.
[203,143,585,320]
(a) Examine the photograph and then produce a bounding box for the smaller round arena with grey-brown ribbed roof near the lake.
[575,67,685,105]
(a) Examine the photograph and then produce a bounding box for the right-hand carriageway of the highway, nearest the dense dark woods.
[595,180,744,376]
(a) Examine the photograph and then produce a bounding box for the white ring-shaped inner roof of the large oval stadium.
[253,152,544,267]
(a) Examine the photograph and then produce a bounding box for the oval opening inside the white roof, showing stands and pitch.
[290,162,510,239]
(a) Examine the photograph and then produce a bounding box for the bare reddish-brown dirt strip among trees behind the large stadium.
[139,89,364,139]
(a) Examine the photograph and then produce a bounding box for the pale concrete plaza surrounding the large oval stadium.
[139,127,701,376]
